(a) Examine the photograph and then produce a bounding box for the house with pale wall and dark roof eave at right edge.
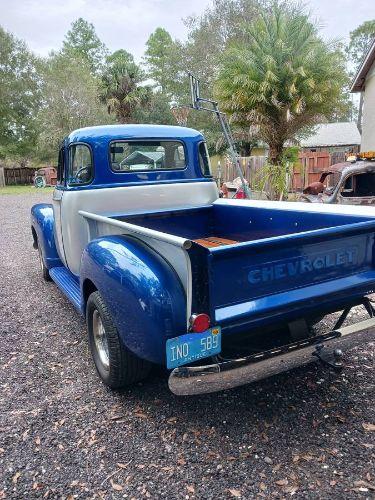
[351,39,375,151]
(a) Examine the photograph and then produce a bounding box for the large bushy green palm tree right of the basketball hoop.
[216,3,346,165]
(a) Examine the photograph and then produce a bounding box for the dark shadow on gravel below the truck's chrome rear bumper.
[113,358,368,447]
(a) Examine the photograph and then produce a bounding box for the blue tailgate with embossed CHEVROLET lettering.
[208,221,375,323]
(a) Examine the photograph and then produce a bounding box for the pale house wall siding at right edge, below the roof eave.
[361,62,375,151]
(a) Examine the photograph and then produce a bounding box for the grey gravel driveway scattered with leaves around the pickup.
[0,193,375,499]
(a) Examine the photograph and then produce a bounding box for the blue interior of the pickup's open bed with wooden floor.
[114,203,375,247]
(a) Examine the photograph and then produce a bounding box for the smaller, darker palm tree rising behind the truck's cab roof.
[100,50,151,123]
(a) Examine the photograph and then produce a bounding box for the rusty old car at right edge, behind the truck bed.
[301,153,375,205]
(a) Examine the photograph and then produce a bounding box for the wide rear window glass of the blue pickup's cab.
[110,141,186,172]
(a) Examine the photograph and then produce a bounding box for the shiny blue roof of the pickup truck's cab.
[67,124,202,143]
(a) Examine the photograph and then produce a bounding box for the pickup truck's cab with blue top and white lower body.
[52,125,218,276]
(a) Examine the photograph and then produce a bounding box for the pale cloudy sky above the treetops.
[0,0,375,61]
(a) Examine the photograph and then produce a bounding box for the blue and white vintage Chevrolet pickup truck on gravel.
[31,125,375,395]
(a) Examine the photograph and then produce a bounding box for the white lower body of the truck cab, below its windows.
[61,182,218,276]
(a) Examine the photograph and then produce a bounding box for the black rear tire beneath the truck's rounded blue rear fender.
[86,292,151,389]
